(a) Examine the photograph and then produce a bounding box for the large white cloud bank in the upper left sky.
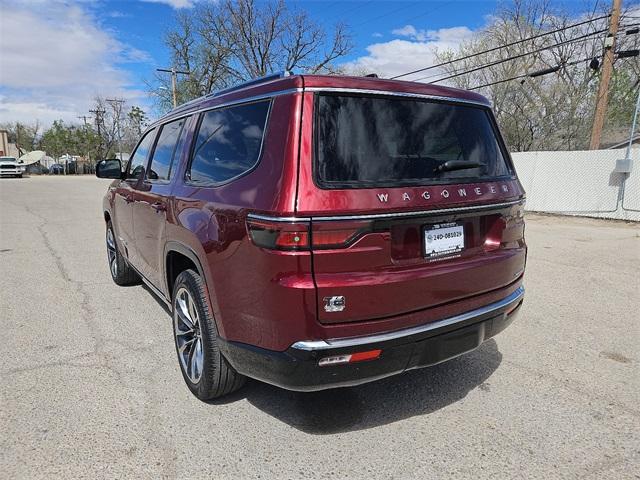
[0,2,150,124]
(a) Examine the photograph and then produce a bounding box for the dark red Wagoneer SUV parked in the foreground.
[96,75,527,399]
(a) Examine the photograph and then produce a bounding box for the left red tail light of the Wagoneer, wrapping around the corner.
[247,218,371,251]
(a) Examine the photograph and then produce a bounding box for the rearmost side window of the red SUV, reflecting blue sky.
[188,101,271,183]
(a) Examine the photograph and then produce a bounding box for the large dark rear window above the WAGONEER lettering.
[315,94,512,188]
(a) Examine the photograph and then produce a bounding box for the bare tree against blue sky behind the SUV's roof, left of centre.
[150,0,352,110]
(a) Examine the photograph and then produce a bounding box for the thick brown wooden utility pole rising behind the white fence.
[589,0,622,150]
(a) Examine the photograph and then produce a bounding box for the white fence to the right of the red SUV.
[511,148,640,221]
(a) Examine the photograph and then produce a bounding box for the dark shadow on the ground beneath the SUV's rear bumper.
[211,340,502,435]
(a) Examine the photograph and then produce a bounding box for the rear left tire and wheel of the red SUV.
[171,270,246,401]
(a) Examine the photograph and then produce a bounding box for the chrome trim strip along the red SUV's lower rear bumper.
[291,287,524,351]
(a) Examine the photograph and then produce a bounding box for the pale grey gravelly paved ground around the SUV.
[0,177,640,480]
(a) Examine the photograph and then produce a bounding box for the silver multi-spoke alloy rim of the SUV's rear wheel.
[173,287,204,384]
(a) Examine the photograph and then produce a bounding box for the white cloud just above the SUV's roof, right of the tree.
[344,25,474,79]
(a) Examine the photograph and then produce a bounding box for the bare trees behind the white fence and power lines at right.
[434,0,640,151]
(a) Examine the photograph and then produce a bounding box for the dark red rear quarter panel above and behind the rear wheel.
[166,93,316,349]
